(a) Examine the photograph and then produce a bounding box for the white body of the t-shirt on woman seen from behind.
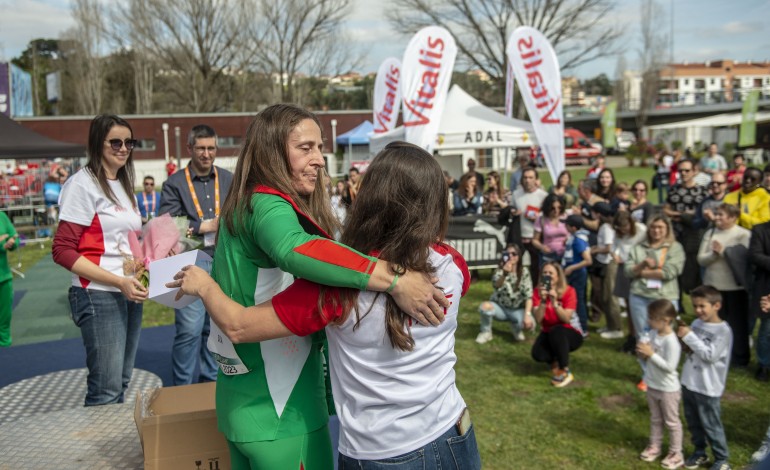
[326,248,467,460]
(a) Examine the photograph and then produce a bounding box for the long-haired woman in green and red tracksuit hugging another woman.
[208,105,448,470]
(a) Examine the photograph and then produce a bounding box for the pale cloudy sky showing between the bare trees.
[0,0,770,78]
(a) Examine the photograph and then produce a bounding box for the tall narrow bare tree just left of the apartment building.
[636,0,668,132]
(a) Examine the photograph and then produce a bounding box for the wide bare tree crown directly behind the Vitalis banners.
[387,0,622,110]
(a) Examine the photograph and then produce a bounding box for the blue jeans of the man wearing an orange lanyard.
[171,300,217,385]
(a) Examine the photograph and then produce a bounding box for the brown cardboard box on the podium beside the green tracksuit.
[134,382,230,470]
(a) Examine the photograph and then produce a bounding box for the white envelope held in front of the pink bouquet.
[149,250,211,308]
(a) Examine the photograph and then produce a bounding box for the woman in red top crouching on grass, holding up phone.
[532,261,583,388]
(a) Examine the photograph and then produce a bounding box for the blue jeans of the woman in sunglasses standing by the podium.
[69,286,142,406]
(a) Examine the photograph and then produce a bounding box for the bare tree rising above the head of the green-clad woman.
[249,0,355,102]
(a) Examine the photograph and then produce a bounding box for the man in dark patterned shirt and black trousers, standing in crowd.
[663,158,704,302]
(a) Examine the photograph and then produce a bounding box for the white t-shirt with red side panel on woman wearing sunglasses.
[59,168,142,292]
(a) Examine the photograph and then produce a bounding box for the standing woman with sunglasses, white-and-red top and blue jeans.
[52,115,147,406]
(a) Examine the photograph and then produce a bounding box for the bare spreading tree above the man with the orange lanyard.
[111,0,253,112]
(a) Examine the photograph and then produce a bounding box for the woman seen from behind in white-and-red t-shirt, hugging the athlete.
[167,142,481,470]
